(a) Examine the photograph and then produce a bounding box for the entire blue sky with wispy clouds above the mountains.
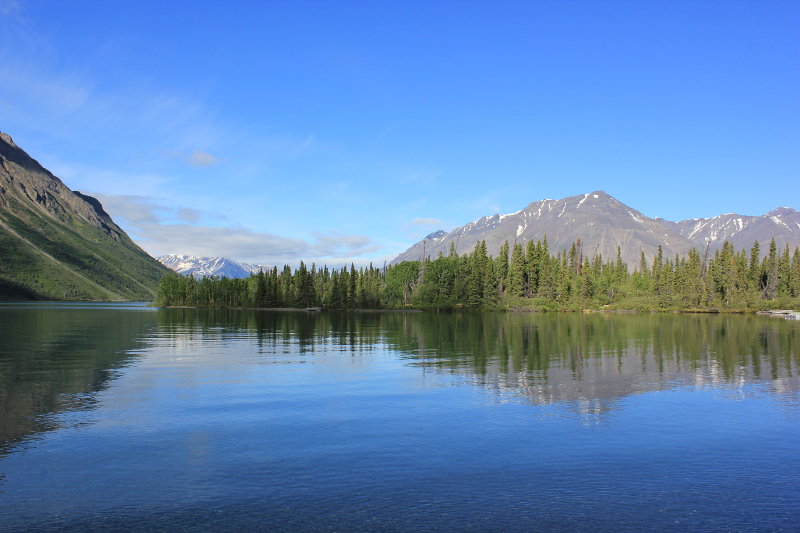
[0,0,800,264]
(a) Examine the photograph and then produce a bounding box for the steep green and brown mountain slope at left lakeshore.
[0,133,168,300]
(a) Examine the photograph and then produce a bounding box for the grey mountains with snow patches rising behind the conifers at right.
[392,191,800,267]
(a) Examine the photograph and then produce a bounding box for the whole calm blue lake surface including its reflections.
[0,304,800,531]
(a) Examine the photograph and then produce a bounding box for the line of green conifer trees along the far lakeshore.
[156,237,800,310]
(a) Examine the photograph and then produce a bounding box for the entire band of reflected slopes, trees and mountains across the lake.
[0,306,800,448]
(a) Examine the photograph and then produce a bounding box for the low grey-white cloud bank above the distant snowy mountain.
[96,194,377,264]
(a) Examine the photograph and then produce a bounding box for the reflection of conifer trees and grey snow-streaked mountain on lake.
[159,310,800,409]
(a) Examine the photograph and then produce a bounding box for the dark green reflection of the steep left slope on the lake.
[0,303,156,453]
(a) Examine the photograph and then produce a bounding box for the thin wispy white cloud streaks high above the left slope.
[0,48,225,156]
